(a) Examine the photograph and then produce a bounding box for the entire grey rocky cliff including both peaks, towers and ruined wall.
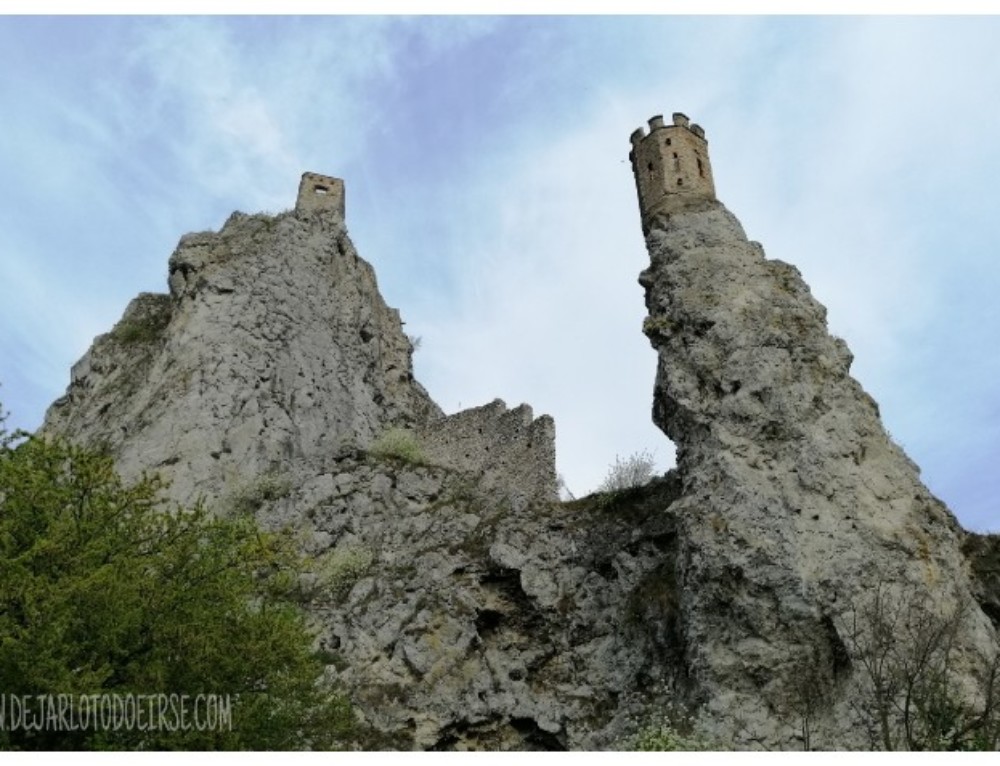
[44,140,1000,749]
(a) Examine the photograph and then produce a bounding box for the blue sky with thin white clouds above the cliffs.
[0,16,1000,530]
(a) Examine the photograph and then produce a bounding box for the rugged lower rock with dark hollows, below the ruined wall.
[258,452,681,750]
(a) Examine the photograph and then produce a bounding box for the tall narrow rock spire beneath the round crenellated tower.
[640,188,997,748]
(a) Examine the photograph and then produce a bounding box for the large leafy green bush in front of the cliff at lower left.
[0,420,355,749]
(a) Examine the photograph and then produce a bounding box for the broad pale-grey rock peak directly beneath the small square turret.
[43,212,442,510]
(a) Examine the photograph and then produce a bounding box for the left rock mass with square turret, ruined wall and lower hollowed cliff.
[44,174,676,749]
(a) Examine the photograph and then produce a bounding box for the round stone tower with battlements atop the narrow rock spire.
[629,112,715,233]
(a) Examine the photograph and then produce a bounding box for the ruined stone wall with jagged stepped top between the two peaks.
[421,399,557,504]
